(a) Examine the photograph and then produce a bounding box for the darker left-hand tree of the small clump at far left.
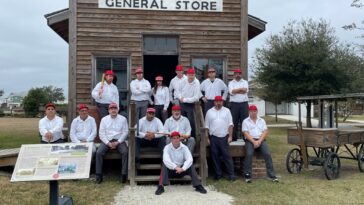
[23,88,47,117]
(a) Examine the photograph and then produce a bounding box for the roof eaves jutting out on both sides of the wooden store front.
[44,8,267,42]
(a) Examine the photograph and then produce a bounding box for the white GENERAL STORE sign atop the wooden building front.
[99,0,223,12]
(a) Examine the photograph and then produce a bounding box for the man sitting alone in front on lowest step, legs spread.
[155,132,207,195]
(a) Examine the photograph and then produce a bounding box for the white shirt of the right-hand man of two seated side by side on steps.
[164,115,191,135]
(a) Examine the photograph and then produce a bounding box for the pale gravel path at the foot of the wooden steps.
[113,185,234,205]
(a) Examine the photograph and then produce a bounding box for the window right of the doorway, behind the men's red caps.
[192,57,225,82]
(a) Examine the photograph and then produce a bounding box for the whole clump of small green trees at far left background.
[23,85,65,117]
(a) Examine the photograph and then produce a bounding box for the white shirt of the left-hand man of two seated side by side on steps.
[137,116,164,138]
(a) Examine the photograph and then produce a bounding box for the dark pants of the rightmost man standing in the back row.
[230,102,249,141]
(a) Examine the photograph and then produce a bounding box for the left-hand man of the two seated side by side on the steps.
[135,108,166,167]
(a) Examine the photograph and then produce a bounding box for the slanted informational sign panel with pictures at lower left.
[10,143,93,182]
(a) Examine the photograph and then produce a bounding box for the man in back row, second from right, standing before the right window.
[201,68,228,115]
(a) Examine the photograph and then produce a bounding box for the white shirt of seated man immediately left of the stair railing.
[99,114,129,144]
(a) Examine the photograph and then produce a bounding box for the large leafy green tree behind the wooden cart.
[253,19,353,127]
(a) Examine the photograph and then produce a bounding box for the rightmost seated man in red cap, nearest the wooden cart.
[242,105,278,183]
